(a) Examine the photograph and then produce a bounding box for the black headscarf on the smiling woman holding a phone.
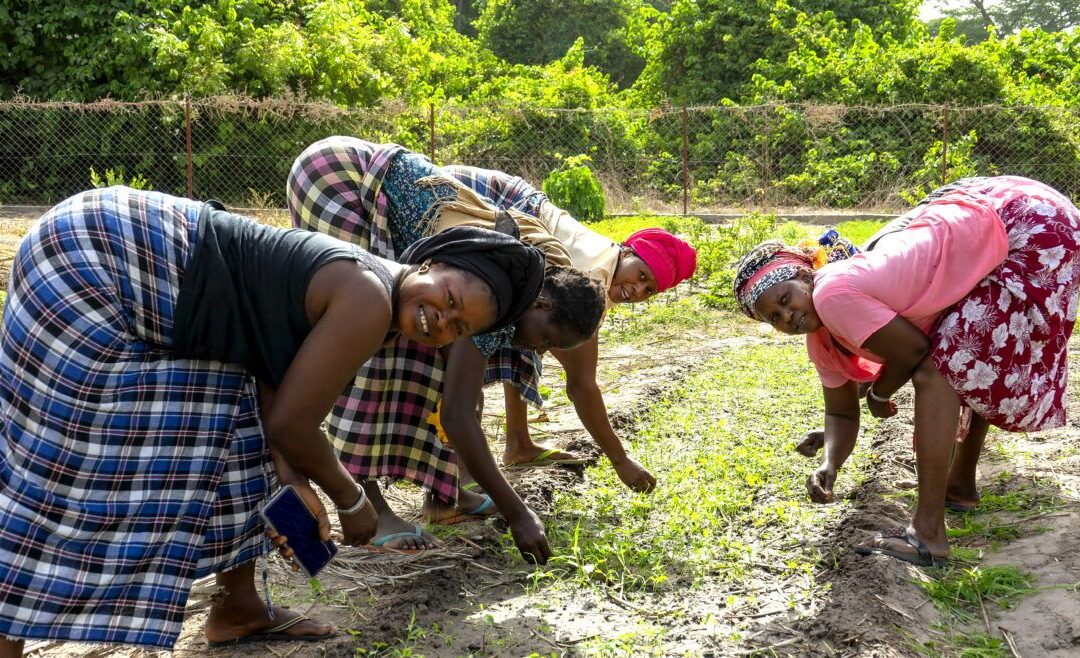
[399,226,544,332]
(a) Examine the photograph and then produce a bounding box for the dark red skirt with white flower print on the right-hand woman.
[929,177,1080,432]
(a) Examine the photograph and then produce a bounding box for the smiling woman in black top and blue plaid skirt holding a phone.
[0,187,543,657]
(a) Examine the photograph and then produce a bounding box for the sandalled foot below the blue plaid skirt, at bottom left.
[204,605,334,644]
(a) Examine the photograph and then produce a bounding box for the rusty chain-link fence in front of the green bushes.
[0,98,1080,213]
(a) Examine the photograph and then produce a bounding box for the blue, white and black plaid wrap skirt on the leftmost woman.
[0,188,273,647]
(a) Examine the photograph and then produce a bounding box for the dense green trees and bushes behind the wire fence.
[0,0,1080,207]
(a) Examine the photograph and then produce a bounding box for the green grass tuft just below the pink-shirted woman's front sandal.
[917,565,1035,621]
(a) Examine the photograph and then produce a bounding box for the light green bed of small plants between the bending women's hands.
[544,339,872,592]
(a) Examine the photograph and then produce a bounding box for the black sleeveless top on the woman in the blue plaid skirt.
[173,202,393,389]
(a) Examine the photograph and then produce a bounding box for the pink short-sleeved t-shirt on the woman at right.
[807,177,1019,388]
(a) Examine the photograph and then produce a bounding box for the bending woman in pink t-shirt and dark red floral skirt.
[734,176,1080,566]
